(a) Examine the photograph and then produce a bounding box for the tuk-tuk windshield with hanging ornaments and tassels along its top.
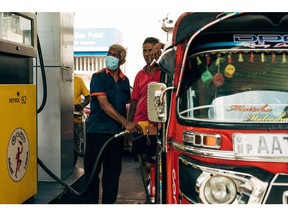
[178,51,288,123]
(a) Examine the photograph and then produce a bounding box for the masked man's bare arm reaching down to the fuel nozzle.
[97,95,142,133]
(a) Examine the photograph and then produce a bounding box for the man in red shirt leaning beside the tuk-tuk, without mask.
[128,37,164,182]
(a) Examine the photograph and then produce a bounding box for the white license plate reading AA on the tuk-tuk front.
[233,133,288,157]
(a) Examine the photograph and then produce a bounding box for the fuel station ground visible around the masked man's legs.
[24,151,146,204]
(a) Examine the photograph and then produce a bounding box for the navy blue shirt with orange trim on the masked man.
[87,68,131,135]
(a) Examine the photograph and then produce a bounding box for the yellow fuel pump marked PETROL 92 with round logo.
[0,12,37,204]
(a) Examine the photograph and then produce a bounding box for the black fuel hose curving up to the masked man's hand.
[37,130,144,196]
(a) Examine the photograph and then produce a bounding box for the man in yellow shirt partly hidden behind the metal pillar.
[74,75,90,166]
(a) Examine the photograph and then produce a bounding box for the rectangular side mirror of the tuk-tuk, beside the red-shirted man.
[147,82,167,122]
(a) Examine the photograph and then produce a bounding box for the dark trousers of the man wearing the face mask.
[84,133,123,204]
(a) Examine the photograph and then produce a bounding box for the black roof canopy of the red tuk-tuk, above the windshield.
[172,12,288,45]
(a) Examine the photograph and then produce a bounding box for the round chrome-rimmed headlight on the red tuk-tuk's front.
[203,176,237,204]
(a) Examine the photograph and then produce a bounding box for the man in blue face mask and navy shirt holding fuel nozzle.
[84,44,141,204]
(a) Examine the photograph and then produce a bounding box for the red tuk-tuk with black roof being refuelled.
[148,12,288,204]
